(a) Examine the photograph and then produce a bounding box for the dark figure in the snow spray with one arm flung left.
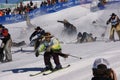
[57,19,77,34]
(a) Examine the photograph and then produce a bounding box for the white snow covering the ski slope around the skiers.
[0,3,120,80]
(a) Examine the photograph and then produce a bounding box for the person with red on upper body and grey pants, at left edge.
[0,25,12,62]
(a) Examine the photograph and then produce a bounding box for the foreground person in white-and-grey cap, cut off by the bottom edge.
[91,58,117,80]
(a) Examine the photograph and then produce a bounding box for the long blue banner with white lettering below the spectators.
[0,0,120,24]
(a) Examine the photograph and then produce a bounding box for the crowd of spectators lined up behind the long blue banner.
[0,0,68,16]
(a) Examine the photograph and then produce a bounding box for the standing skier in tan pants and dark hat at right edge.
[106,13,120,41]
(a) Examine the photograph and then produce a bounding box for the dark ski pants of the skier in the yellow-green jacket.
[44,51,60,67]
